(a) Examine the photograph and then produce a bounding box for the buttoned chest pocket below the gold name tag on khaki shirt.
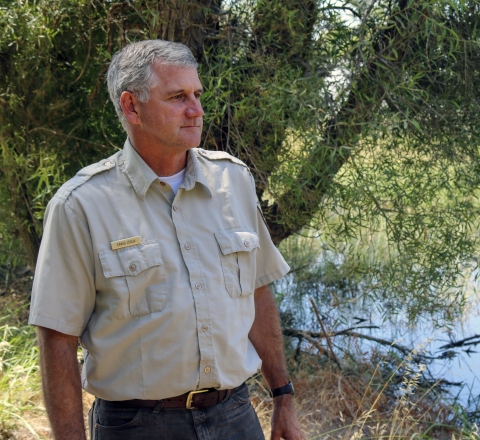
[99,240,168,318]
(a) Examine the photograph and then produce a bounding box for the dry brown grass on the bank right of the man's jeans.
[250,338,480,440]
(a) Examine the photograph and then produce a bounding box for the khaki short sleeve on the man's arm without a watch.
[28,197,95,336]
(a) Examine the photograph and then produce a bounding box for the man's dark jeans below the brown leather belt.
[89,384,265,440]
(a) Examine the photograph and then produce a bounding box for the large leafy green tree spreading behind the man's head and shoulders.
[0,0,480,320]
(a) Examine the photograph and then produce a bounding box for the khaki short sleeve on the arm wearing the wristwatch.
[255,208,290,289]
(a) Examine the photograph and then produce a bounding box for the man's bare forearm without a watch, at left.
[37,327,86,440]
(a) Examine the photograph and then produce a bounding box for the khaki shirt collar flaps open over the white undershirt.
[123,138,212,200]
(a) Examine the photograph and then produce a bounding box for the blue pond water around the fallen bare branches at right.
[277,276,480,412]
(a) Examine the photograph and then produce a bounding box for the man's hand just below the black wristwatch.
[270,394,304,440]
